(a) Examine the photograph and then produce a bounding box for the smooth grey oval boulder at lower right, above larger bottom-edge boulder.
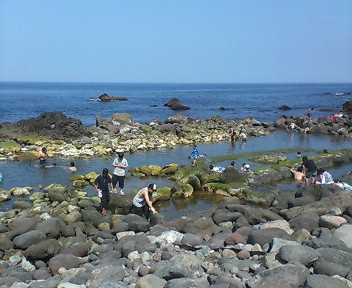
[278,245,319,266]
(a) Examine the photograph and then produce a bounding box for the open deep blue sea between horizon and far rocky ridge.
[0,82,352,126]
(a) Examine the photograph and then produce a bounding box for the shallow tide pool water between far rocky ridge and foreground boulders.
[0,131,352,218]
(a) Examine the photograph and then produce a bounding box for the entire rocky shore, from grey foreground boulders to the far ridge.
[0,109,352,288]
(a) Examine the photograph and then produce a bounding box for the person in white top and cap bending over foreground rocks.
[132,183,158,219]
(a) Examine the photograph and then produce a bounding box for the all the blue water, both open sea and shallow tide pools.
[0,82,352,218]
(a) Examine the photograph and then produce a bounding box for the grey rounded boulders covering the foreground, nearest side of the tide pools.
[0,175,352,288]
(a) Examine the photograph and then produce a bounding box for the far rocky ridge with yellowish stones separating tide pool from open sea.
[0,108,352,161]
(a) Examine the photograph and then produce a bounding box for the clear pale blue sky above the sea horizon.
[0,0,352,83]
